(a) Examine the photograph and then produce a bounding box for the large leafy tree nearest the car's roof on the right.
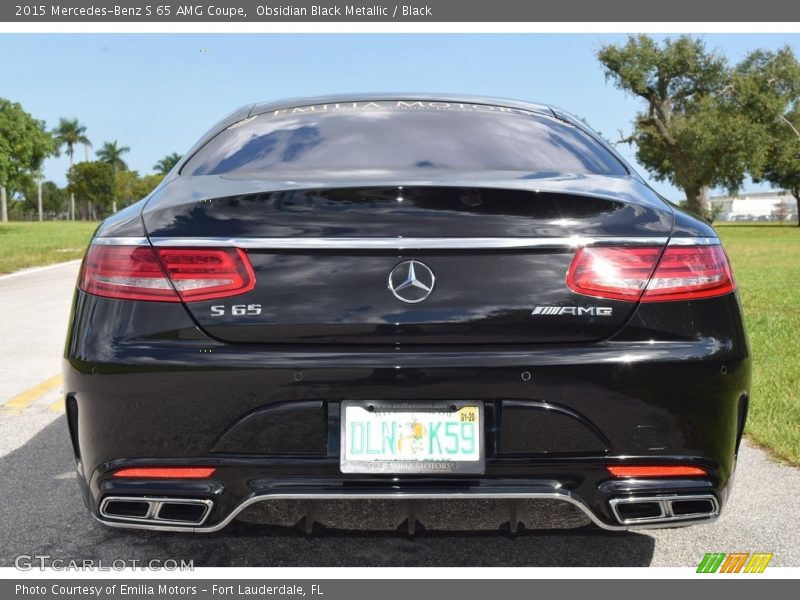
[597,35,768,216]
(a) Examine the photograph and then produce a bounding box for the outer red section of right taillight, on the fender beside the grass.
[642,246,734,302]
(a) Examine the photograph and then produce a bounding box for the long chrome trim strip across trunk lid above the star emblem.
[150,236,668,250]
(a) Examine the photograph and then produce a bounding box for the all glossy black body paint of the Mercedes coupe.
[65,99,750,525]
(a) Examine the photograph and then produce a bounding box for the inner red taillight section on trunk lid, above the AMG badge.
[567,247,661,302]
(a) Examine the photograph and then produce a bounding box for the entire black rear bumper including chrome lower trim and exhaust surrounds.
[65,293,750,532]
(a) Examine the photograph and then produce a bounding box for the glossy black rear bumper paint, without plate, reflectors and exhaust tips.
[67,292,750,523]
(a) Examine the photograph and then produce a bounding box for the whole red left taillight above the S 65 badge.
[78,245,255,302]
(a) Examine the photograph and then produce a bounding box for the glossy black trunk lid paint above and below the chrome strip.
[144,179,673,344]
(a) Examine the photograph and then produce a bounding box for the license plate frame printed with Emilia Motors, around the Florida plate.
[339,400,486,475]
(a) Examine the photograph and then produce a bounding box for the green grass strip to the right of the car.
[716,224,800,464]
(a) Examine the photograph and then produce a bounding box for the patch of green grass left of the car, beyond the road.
[0,221,97,273]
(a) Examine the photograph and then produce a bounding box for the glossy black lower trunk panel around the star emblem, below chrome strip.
[190,252,634,345]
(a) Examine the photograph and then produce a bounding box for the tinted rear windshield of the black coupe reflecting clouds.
[182,101,627,175]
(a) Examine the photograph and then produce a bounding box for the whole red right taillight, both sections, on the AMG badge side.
[567,246,734,302]
